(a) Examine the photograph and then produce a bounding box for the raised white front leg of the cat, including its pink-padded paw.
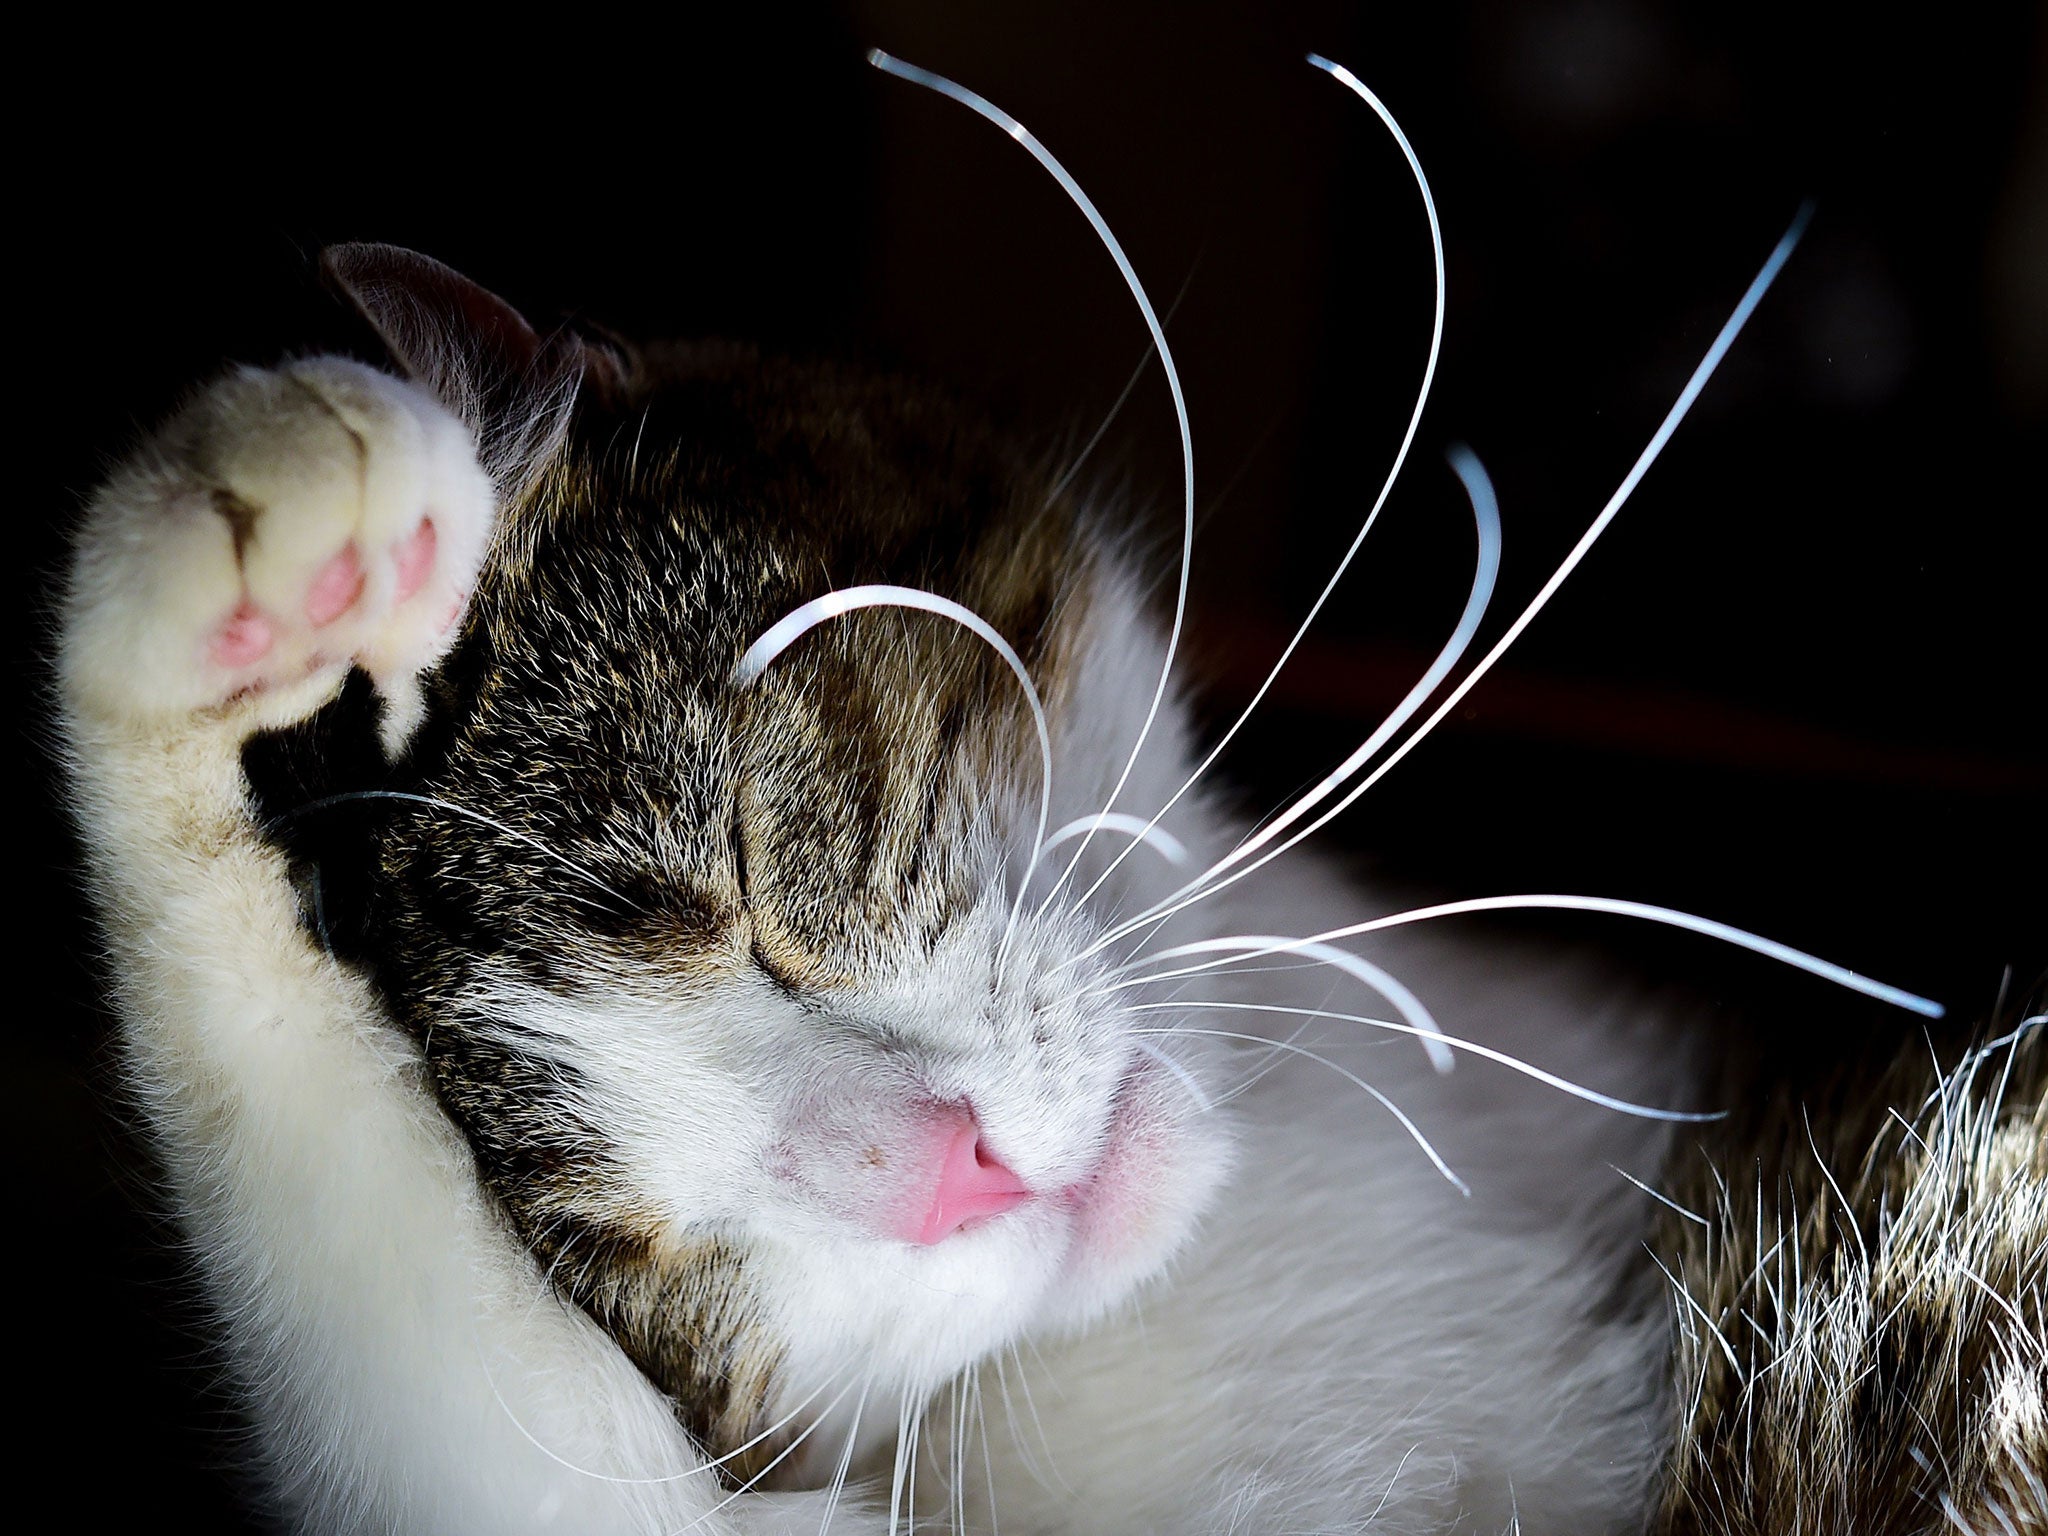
[61,358,831,1536]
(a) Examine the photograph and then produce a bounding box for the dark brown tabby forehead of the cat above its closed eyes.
[405,348,1092,981]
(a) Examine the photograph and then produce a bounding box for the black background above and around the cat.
[8,0,2048,1530]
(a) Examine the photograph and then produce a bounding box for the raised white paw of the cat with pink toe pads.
[66,356,496,717]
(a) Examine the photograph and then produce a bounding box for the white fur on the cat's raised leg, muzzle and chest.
[63,360,1679,1536]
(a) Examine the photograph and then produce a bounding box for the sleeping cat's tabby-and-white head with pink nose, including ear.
[264,248,1225,1474]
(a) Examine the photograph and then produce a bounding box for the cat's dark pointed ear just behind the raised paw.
[319,244,625,498]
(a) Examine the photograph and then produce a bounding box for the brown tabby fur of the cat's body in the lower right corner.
[1651,1011,2048,1536]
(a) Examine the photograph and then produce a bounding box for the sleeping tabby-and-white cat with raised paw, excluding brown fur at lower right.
[61,57,2038,1532]
